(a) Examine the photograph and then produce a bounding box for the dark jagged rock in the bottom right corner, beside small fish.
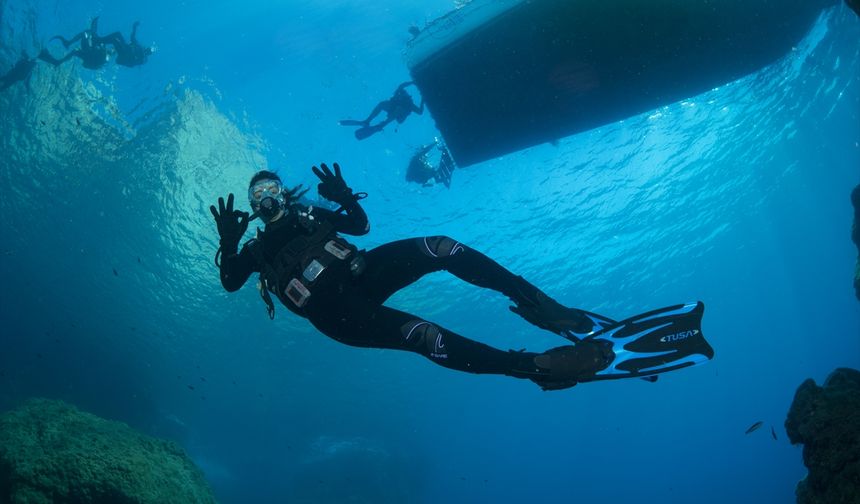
[785,368,860,504]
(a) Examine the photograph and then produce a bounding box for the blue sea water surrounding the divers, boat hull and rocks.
[5,0,860,503]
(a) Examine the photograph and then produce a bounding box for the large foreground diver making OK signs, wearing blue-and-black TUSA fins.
[209,163,713,390]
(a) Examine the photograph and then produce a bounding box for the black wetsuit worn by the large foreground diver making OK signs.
[221,199,537,374]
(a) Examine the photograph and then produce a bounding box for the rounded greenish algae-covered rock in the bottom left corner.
[0,399,216,504]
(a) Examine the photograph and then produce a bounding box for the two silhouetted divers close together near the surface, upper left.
[38,17,155,70]
